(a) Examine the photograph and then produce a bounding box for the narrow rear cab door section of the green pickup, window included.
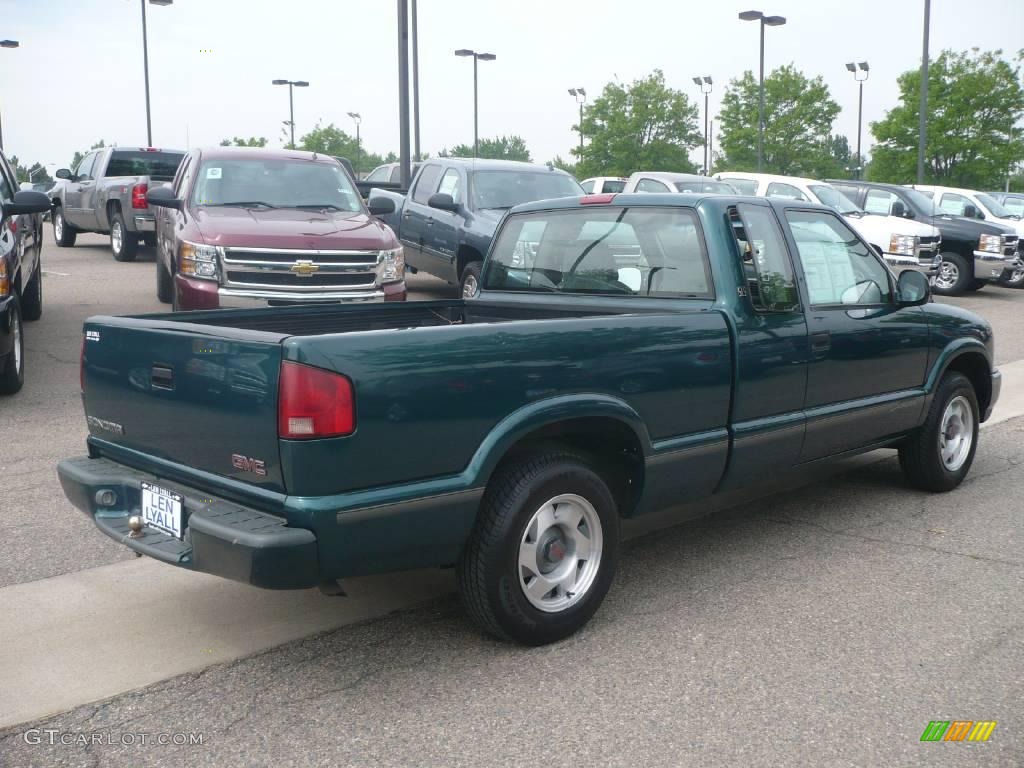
[721,203,809,488]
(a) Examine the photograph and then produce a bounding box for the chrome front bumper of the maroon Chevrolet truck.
[174,274,407,309]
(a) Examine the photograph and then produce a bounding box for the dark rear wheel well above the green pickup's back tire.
[495,417,644,517]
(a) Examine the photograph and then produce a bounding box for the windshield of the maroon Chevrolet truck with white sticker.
[191,158,362,213]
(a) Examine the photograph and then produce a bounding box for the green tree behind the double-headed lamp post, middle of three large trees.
[717,65,849,178]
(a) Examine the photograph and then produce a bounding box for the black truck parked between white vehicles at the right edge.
[828,179,1024,296]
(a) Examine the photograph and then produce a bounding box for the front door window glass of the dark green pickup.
[785,211,892,306]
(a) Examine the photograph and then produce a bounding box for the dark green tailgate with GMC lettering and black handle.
[82,317,286,492]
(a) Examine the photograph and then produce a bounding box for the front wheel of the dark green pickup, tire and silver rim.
[899,372,981,493]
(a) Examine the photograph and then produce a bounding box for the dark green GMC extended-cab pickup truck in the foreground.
[58,195,1000,644]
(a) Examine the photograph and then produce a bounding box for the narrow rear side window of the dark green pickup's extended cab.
[730,204,800,312]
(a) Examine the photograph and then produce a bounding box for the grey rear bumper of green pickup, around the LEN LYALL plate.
[57,457,319,589]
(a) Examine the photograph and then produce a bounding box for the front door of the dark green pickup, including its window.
[785,208,929,461]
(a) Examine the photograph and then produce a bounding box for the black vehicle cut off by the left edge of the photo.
[0,153,50,394]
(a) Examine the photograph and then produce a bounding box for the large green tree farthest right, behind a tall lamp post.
[871,48,1024,189]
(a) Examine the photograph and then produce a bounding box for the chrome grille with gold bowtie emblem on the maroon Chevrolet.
[220,248,378,294]
